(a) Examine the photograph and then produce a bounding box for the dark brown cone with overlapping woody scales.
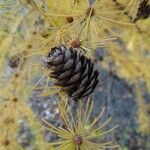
[44,45,99,100]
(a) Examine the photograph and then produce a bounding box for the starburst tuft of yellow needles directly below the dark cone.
[43,99,119,150]
